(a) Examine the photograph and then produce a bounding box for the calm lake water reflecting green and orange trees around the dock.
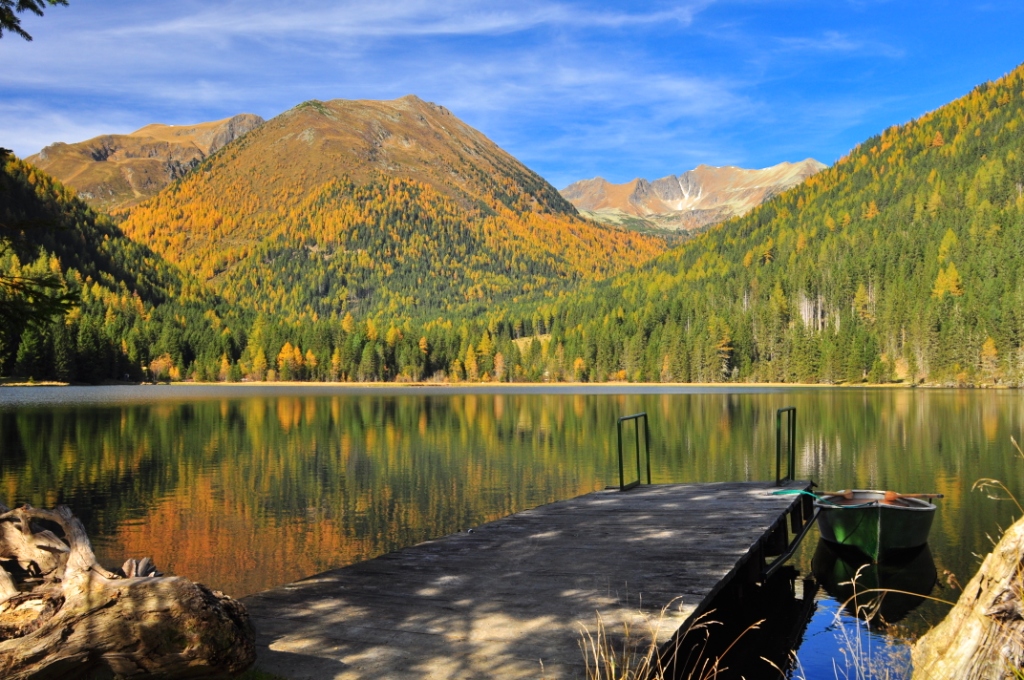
[0,385,1024,679]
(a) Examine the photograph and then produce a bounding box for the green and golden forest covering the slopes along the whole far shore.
[6,63,1024,386]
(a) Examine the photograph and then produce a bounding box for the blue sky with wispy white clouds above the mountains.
[0,0,1024,188]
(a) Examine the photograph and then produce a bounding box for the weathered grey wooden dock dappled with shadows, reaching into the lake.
[243,482,809,680]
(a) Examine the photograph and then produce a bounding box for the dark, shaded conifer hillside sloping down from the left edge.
[0,157,244,382]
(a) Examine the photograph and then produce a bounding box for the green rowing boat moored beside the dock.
[814,491,935,561]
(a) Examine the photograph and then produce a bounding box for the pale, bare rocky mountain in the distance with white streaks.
[561,159,825,231]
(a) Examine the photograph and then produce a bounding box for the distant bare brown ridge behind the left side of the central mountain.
[26,114,263,210]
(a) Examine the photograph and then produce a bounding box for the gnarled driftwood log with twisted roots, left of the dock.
[0,505,256,680]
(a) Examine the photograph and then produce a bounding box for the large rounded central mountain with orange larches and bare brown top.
[123,96,664,316]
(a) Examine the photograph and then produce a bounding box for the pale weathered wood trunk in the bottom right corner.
[913,518,1024,680]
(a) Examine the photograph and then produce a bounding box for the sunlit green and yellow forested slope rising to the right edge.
[523,68,1024,384]
